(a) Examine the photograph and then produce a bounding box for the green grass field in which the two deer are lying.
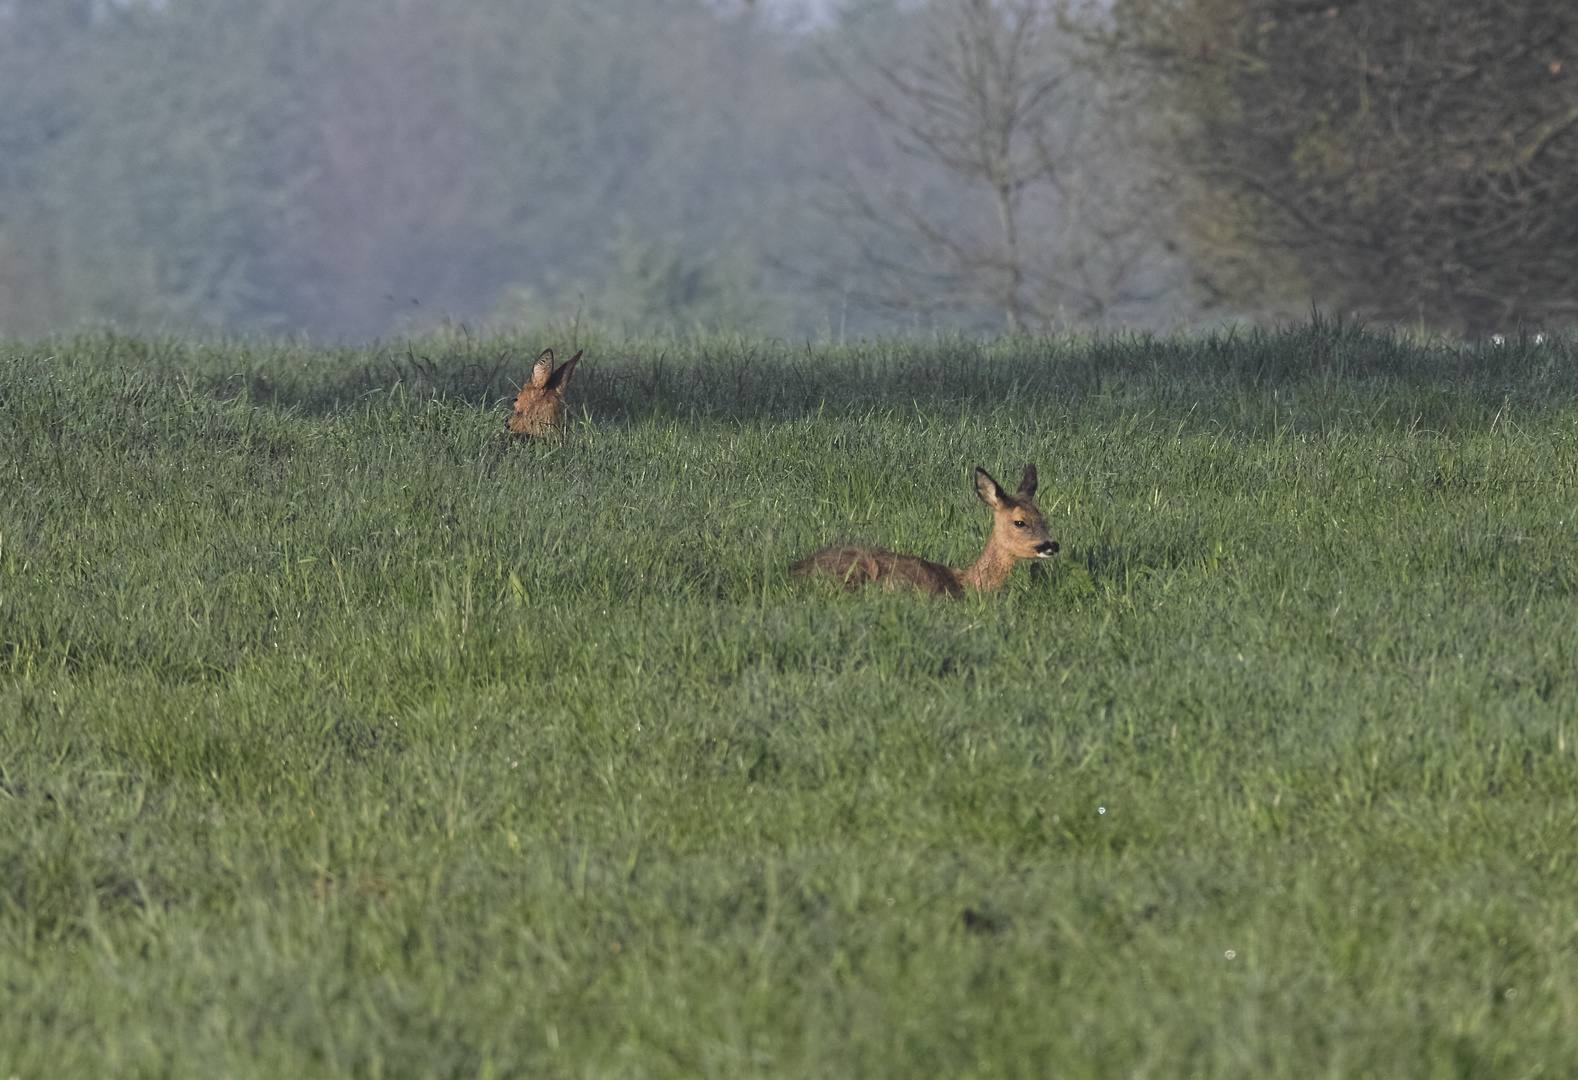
[0,324,1578,1080]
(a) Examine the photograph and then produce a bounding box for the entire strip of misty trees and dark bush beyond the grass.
[0,0,1578,338]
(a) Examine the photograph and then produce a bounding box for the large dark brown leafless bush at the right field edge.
[1117,0,1578,333]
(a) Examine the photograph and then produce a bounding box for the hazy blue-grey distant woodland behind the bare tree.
[0,0,1192,339]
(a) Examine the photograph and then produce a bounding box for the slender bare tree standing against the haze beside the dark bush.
[838,0,1168,332]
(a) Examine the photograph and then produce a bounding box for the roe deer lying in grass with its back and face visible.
[789,464,1057,597]
